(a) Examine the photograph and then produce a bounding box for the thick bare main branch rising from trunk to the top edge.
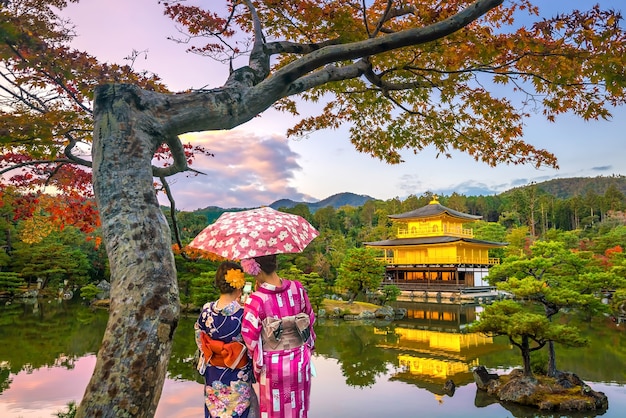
[143,0,503,141]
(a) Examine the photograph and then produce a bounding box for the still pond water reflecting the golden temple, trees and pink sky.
[0,300,626,418]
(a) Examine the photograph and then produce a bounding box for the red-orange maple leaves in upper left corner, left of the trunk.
[0,0,210,208]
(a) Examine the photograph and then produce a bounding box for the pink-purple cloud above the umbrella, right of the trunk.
[161,130,314,210]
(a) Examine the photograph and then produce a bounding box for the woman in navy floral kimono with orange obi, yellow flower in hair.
[195,261,258,418]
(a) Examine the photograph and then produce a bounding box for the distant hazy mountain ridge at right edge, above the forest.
[502,175,626,199]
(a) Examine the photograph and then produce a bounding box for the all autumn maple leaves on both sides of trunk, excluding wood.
[0,0,626,204]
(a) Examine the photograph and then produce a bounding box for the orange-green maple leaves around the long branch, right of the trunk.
[161,0,626,167]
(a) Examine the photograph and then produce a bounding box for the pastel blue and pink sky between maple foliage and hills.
[63,0,626,211]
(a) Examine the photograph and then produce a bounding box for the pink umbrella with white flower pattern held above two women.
[189,207,319,260]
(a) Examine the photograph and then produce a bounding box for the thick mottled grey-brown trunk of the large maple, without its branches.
[76,85,180,418]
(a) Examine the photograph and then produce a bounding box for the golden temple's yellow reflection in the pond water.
[381,302,510,394]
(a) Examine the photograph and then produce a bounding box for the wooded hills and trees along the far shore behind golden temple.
[0,176,626,298]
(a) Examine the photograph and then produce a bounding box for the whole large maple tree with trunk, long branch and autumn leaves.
[0,0,626,417]
